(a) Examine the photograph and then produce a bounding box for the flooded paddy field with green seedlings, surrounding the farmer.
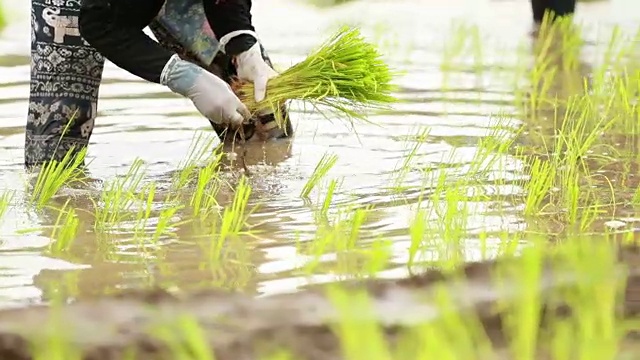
[0,0,640,359]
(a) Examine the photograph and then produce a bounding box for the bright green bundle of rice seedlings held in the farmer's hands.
[232,27,396,127]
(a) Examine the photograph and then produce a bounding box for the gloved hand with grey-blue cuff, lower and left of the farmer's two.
[160,54,251,127]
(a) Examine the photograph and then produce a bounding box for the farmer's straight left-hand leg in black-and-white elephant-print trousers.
[24,0,104,166]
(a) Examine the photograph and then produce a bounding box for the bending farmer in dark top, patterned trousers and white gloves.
[25,0,292,166]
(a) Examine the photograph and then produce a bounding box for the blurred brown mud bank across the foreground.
[0,246,640,360]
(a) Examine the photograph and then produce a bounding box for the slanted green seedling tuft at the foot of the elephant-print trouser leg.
[30,147,87,209]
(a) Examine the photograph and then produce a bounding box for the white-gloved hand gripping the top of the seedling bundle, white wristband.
[233,42,278,102]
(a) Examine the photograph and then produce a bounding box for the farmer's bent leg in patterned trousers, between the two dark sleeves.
[149,0,293,141]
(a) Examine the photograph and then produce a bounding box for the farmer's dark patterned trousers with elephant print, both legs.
[24,0,293,167]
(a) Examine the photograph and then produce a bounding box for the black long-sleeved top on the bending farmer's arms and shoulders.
[79,0,256,83]
